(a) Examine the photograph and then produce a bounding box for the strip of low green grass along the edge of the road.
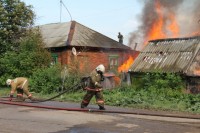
[0,86,200,114]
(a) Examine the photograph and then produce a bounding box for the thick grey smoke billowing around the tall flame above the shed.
[129,0,200,50]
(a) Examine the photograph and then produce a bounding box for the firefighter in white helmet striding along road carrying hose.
[81,64,105,110]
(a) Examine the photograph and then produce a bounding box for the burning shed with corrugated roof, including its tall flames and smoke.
[125,0,200,93]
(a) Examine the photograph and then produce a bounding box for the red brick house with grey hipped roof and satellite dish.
[39,21,139,89]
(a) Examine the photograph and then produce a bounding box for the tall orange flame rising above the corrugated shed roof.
[144,0,179,45]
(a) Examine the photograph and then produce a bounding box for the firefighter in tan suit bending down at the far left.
[6,77,34,101]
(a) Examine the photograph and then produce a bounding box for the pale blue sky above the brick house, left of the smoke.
[21,0,142,45]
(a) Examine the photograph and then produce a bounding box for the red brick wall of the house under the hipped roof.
[57,49,138,73]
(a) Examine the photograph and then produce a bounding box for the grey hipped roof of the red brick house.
[39,21,130,49]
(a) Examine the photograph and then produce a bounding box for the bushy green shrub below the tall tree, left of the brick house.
[0,30,51,85]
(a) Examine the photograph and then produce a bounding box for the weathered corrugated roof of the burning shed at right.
[130,37,200,76]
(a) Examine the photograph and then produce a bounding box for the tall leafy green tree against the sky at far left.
[0,0,35,54]
